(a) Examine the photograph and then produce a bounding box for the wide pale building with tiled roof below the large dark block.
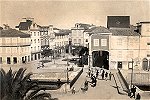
[109,28,140,69]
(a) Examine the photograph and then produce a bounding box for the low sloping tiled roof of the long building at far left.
[0,28,30,38]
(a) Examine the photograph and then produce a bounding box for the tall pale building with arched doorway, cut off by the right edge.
[137,21,150,70]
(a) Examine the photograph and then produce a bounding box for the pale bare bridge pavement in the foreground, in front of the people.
[58,69,129,100]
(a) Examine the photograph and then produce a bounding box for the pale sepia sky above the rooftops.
[0,0,150,28]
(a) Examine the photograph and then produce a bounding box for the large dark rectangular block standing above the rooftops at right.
[107,16,130,28]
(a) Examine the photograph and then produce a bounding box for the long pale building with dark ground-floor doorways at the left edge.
[0,27,31,64]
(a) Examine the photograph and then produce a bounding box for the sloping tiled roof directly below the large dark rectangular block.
[109,28,140,36]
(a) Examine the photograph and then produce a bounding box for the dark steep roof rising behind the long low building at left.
[18,20,32,30]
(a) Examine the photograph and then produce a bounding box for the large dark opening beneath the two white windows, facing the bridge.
[92,51,109,69]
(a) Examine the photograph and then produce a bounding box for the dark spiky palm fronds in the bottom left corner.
[0,68,52,100]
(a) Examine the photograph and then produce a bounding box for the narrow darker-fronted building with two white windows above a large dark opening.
[88,26,111,69]
